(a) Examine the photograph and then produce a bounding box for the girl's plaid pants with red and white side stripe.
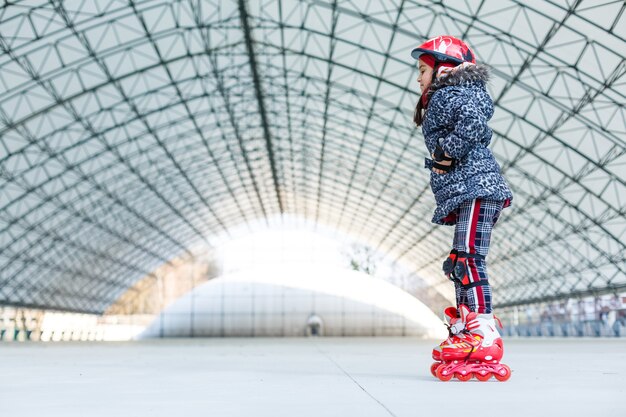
[453,199,504,314]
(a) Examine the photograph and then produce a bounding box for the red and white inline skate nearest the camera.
[431,308,511,381]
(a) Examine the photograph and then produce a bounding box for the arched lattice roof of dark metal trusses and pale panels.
[0,0,626,312]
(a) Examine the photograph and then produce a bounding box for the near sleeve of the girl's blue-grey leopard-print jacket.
[439,94,489,159]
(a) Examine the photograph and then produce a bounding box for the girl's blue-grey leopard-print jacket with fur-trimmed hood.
[422,64,513,225]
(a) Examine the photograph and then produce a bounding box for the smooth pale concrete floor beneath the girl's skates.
[0,338,626,417]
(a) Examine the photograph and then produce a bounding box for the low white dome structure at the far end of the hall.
[141,268,445,338]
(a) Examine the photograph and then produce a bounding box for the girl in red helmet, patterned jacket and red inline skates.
[411,36,513,380]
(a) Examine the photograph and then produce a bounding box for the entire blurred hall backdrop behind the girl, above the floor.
[0,0,626,342]
